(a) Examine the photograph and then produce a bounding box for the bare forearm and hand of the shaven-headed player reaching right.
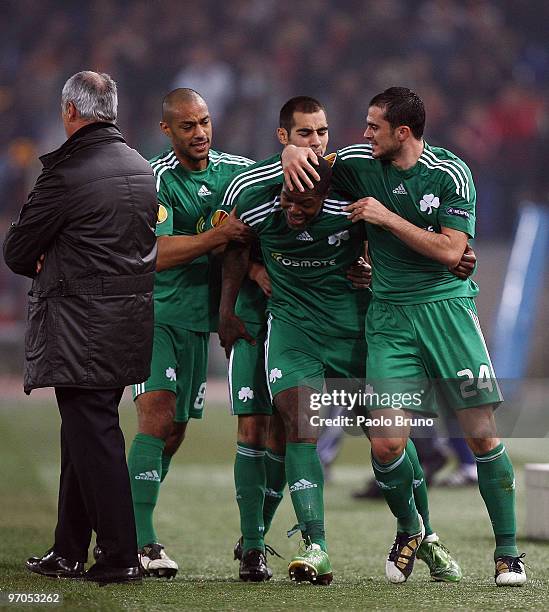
[156,211,254,272]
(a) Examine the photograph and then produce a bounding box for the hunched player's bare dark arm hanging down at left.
[218,237,255,358]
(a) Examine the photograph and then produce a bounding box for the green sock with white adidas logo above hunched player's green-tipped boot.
[286,442,327,551]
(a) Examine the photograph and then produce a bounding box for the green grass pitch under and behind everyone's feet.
[0,390,549,611]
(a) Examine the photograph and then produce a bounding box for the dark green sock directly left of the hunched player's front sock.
[234,442,265,552]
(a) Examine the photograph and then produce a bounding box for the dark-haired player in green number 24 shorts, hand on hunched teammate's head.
[280,87,526,586]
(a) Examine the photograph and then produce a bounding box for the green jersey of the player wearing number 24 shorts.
[332,143,478,304]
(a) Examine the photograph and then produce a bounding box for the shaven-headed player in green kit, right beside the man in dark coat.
[128,88,252,577]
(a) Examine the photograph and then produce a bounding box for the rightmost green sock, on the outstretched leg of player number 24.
[475,443,518,559]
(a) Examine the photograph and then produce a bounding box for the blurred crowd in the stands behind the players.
[0,0,549,320]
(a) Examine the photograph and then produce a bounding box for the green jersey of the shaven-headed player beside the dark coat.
[150,149,253,332]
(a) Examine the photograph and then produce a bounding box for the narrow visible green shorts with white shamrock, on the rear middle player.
[228,323,273,416]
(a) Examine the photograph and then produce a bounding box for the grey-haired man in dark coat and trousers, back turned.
[4,71,157,582]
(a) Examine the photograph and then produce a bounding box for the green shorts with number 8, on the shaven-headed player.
[133,324,210,423]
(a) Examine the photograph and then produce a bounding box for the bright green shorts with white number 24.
[366,297,503,414]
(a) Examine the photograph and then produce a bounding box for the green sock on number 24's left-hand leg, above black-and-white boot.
[372,451,420,534]
